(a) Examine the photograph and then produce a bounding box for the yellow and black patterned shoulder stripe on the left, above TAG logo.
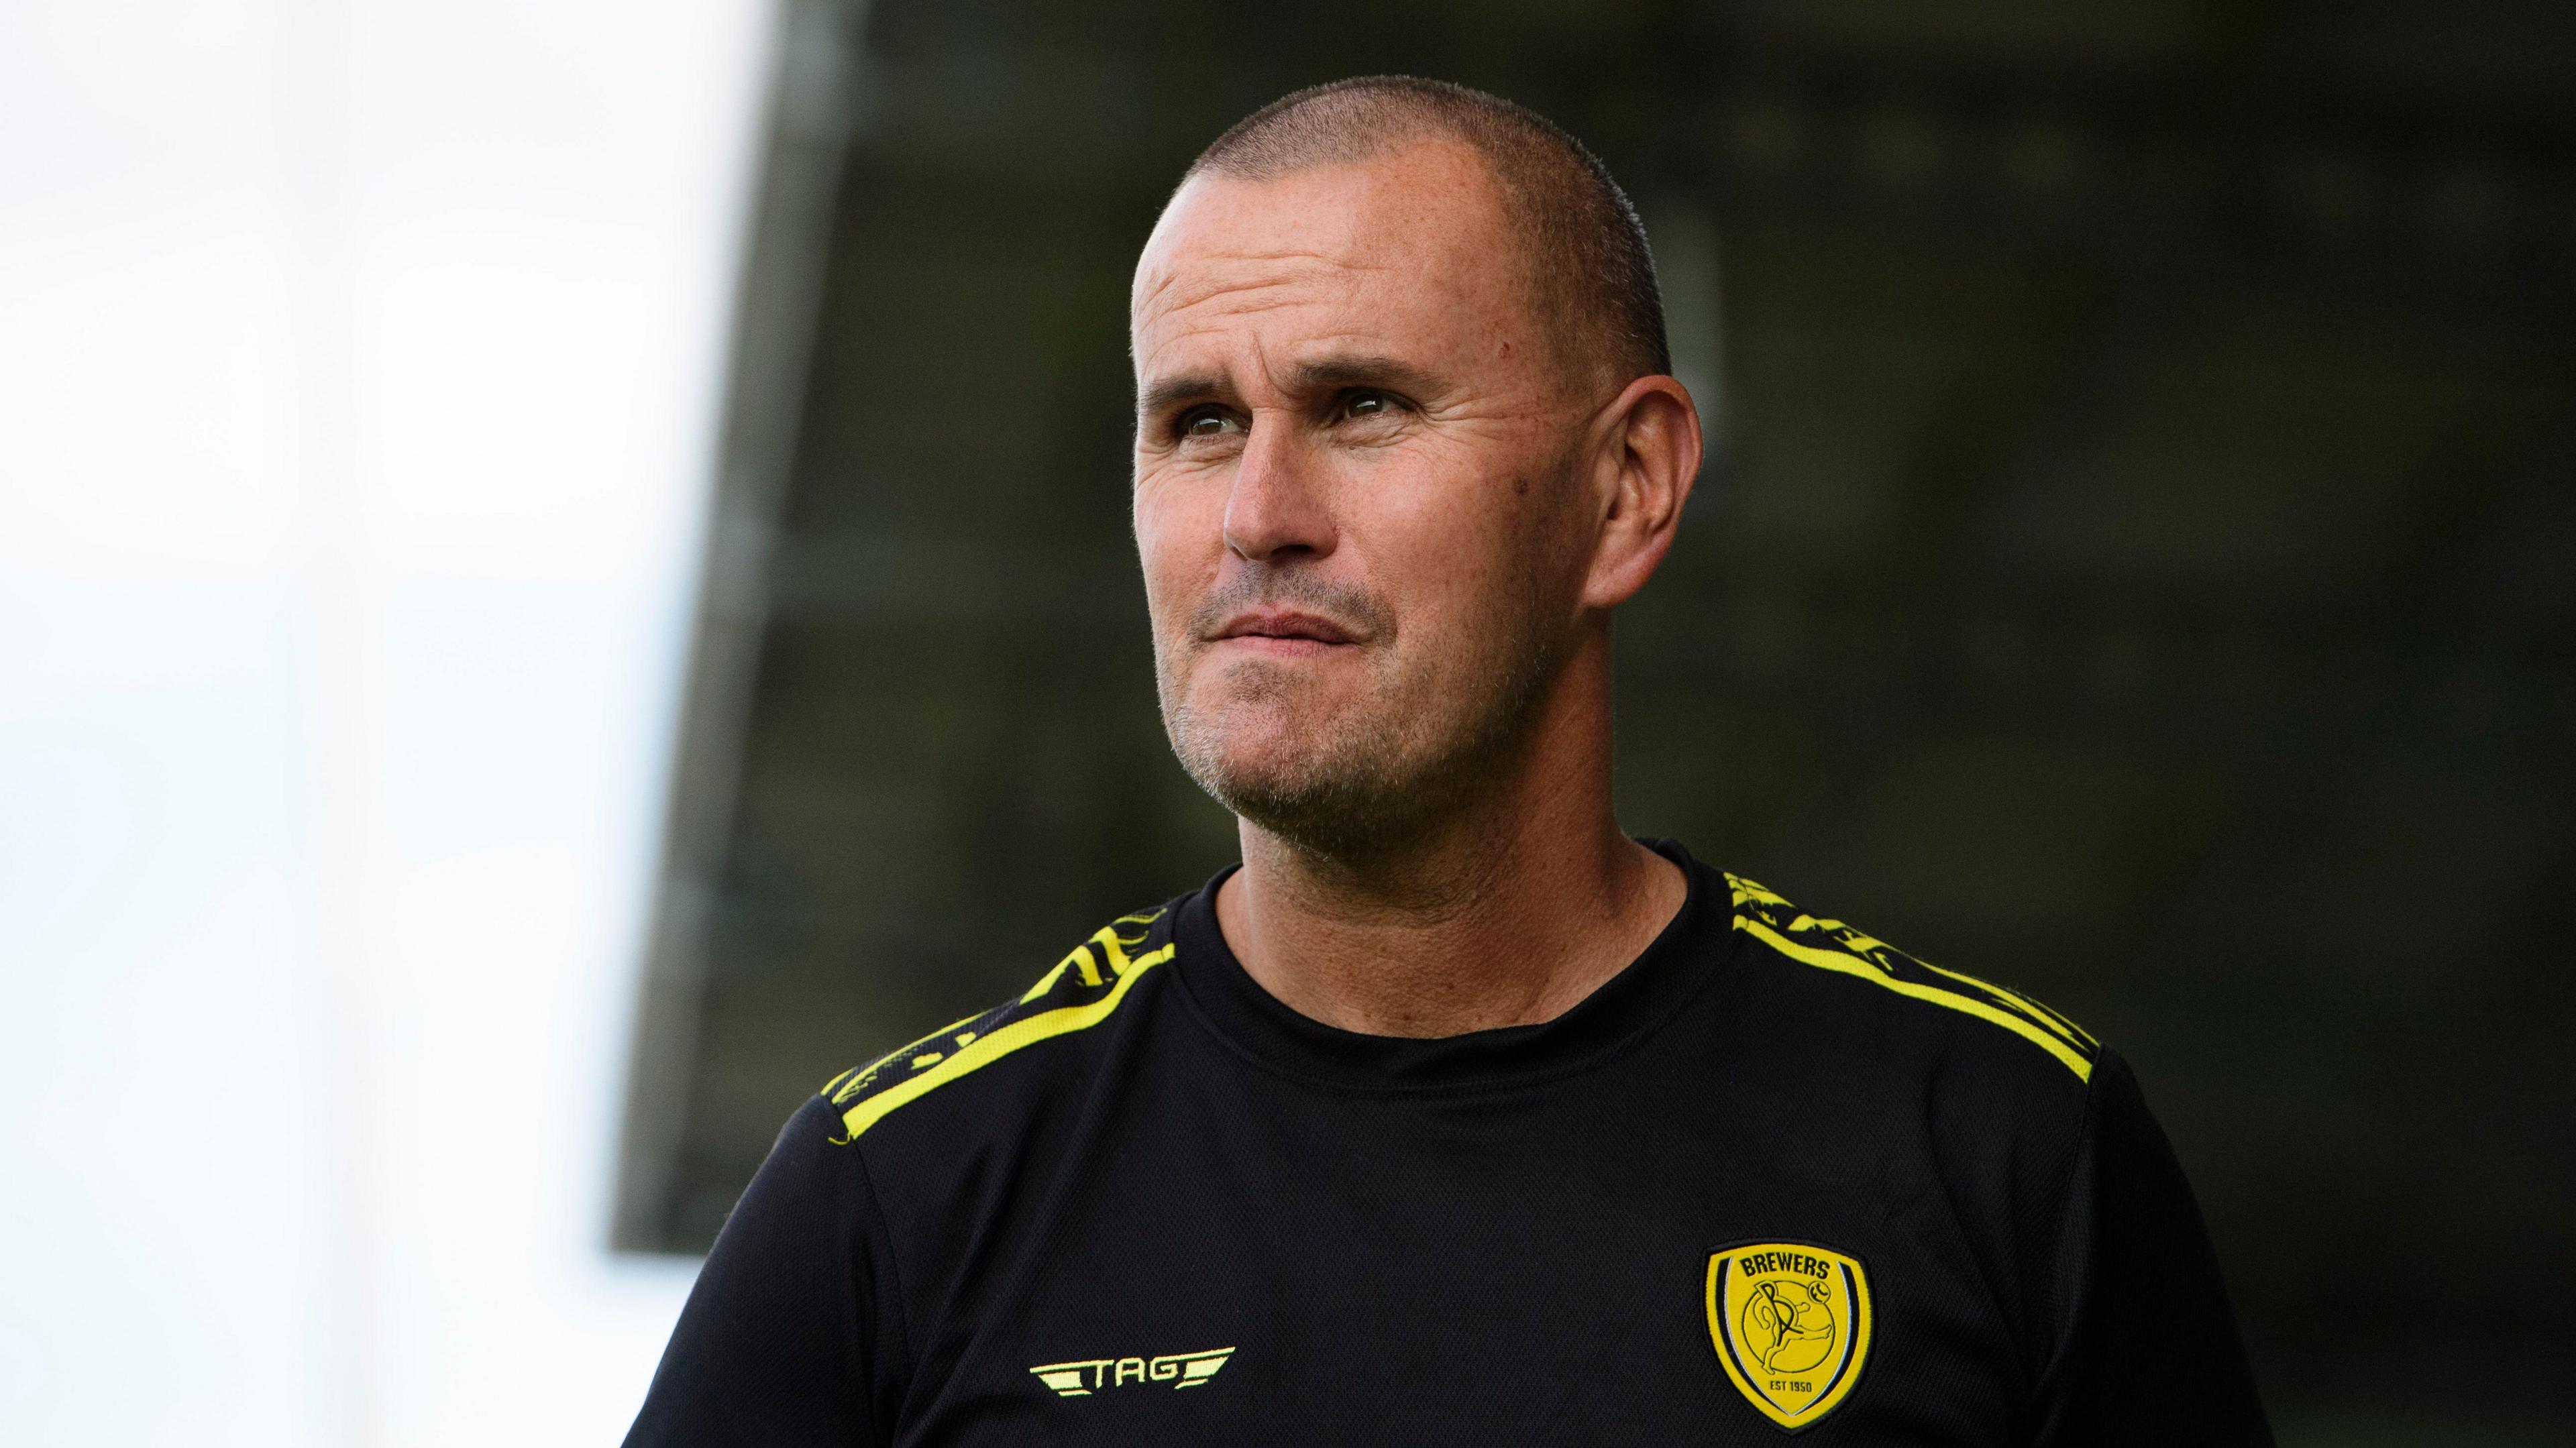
[822,909,1172,1144]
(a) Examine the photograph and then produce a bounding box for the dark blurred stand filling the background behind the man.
[616,0,2576,1445]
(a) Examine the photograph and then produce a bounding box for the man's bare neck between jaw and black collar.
[1216,636,1687,1036]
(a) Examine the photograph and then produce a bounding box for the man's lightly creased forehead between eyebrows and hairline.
[1131,142,1527,374]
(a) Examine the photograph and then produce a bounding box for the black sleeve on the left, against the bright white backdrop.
[626,1098,899,1448]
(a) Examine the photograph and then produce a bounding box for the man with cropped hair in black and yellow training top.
[629,80,2269,1445]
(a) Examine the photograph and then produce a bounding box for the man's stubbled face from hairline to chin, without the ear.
[1134,142,1595,845]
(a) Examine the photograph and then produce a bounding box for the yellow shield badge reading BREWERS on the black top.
[1708,1242,1876,1433]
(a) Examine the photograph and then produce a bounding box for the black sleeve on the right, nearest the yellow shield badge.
[2037,1051,2272,1448]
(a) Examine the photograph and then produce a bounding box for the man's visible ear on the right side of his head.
[1585,376,1700,608]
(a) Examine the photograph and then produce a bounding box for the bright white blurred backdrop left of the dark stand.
[0,0,770,1448]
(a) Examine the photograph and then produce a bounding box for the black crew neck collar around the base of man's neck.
[1172,840,1726,1090]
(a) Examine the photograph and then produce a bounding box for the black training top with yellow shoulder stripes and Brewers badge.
[626,845,2272,1448]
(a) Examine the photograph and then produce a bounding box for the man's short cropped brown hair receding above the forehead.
[1180,74,1672,382]
